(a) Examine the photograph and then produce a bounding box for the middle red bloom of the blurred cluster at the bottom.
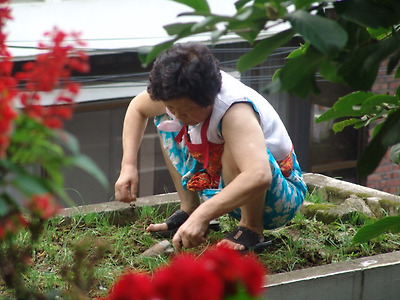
[153,254,223,300]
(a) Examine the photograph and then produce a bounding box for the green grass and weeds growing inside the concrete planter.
[0,200,400,297]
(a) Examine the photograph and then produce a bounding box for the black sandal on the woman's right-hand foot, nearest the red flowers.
[224,226,272,253]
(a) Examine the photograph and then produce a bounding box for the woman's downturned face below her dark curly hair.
[164,97,212,125]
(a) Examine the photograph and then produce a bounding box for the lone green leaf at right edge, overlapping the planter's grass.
[353,215,400,243]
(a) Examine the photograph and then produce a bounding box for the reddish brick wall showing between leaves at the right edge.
[366,64,400,195]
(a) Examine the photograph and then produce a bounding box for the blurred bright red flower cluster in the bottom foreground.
[101,247,266,300]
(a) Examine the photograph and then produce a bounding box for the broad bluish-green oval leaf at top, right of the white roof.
[287,10,347,56]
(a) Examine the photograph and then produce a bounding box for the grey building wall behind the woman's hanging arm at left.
[64,94,175,206]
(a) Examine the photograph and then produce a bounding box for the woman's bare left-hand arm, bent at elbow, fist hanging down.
[115,91,165,202]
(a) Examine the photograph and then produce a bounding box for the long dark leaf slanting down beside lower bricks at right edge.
[357,109,400,178]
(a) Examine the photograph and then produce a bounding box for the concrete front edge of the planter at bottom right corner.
[265,251,400,300]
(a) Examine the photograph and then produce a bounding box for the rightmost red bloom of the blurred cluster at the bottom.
[201,246,266,296]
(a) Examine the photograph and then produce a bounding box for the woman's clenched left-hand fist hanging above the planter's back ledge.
[115,166,139,203]
